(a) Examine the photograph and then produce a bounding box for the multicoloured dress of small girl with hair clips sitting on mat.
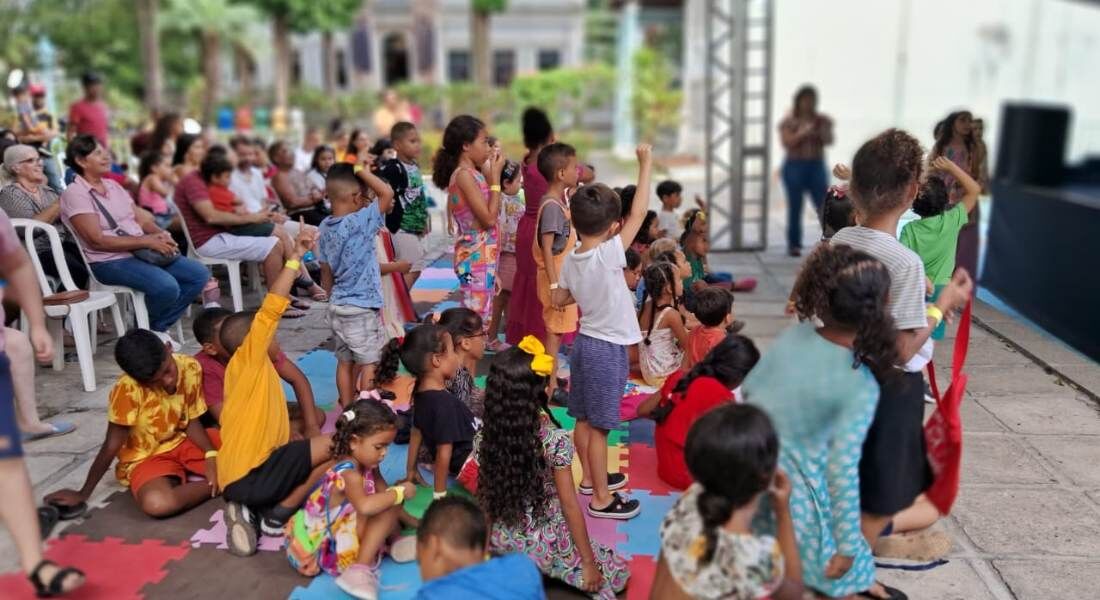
[286,460,374,577]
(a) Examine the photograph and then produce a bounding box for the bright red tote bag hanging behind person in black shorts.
[924,301,972,515]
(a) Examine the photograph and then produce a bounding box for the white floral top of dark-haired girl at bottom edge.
[661,483,783,600]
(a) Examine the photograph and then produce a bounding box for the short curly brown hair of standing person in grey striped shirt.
[849,129,924,217]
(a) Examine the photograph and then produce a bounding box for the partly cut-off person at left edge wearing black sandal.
[0,205,84,597]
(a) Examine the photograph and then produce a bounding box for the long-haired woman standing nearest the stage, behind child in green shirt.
[930,110,985,287]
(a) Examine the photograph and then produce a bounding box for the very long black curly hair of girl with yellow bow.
[477,347,561,526]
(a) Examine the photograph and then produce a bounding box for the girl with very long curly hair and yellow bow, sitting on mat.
[476,336,630,599]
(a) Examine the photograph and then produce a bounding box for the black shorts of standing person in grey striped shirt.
[859,371,932,515]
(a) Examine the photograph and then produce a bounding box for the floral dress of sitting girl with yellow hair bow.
[488,419,630,600]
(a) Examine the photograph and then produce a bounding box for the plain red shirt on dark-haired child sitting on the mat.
[655,371,734,490]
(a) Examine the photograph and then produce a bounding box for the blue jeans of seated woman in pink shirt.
[91,257,210,331]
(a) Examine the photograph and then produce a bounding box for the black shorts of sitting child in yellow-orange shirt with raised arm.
[222,439,314,511]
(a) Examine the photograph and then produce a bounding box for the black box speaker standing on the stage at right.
[994,103,1069,187]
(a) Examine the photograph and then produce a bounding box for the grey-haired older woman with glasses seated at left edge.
[0,144,88,290]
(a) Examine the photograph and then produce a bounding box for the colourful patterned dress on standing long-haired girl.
[447,168,501,323]
